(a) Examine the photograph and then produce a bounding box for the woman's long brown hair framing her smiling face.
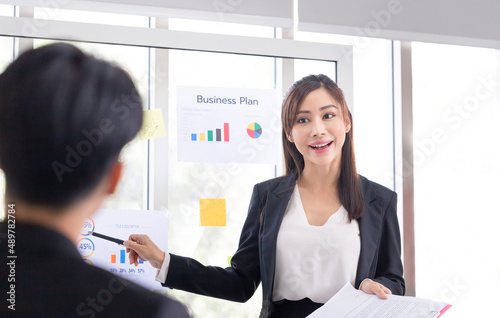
[281,74,365,220]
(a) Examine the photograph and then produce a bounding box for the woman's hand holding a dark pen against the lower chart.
[123,234,165,269]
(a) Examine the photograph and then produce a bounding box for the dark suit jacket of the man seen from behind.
[0,222,189,318]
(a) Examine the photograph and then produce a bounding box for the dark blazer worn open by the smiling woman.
[164,174,405,318]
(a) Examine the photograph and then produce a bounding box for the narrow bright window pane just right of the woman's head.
[352,39,396,190]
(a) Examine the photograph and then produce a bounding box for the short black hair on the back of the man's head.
[0,43,142,210]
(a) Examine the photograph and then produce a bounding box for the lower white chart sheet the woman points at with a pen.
[76,209,167,290]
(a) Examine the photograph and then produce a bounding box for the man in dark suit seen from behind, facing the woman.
[0,43,189,318]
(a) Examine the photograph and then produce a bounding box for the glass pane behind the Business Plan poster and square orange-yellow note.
[166,50,281,318]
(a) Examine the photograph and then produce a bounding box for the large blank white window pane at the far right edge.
[412,43,500,318]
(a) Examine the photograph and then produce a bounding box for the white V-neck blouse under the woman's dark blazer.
[273,186,361,303]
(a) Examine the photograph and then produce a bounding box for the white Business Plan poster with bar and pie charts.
[177,86,281,164]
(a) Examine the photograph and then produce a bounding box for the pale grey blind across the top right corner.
[298,0,500,47]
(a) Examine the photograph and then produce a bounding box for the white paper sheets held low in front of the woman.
[307,283,451,318]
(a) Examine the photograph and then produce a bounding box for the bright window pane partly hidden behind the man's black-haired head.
[34,39,149,210]
